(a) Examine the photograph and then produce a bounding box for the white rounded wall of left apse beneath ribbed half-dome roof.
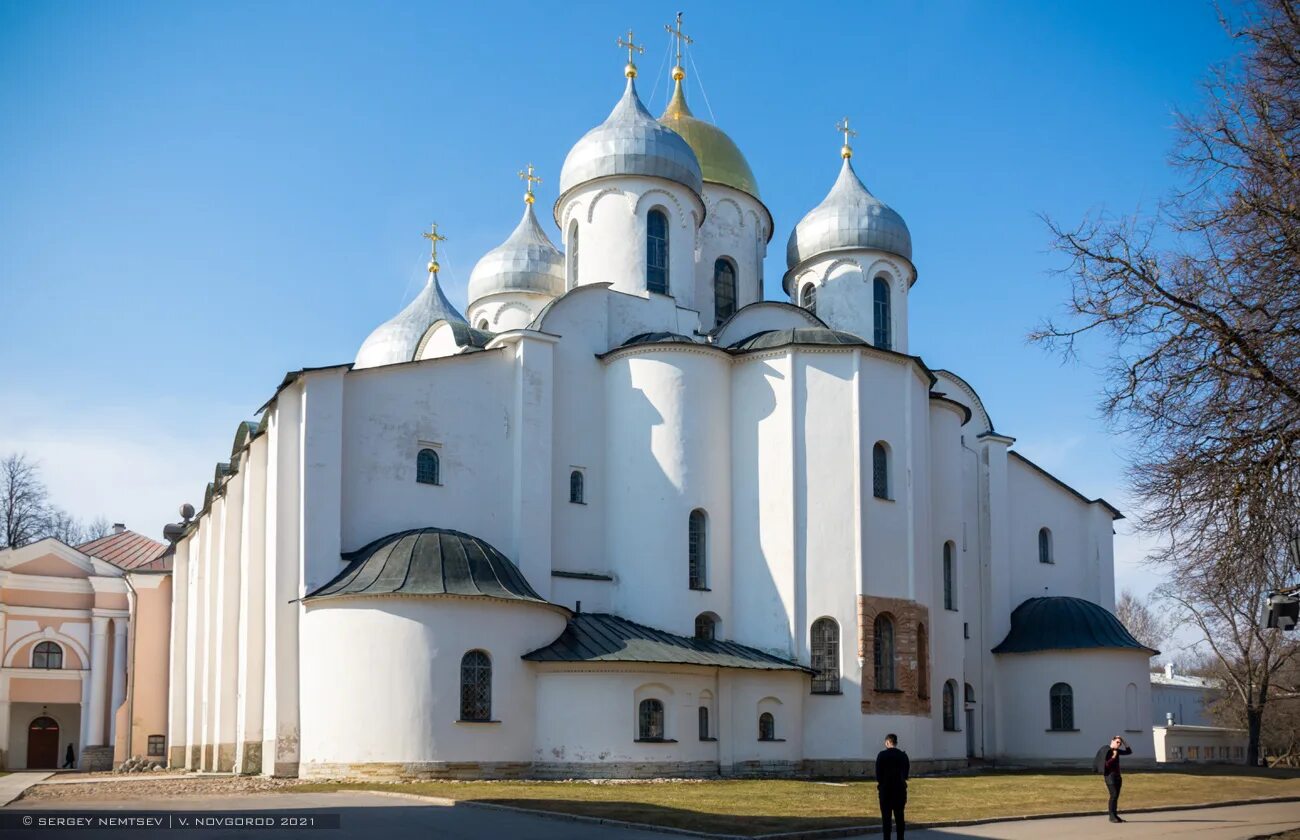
[302,597,572,776]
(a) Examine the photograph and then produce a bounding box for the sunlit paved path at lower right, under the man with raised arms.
[899,802,1300,840]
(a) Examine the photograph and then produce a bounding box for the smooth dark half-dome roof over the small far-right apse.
[993,596,1160,654]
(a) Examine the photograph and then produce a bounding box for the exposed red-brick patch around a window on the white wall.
[858,596,933,716]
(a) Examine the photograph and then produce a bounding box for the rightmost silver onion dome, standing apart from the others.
[785,157,911,269]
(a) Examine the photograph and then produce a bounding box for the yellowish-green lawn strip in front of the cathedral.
[286,767,1300,835]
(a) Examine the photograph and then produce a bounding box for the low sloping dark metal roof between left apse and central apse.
[524,612,809,671]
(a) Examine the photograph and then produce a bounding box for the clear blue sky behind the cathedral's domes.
[0,0,1234,652]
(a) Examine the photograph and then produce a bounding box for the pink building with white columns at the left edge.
[0,525,172,770]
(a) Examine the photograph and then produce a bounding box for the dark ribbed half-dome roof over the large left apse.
[303,528,547,603]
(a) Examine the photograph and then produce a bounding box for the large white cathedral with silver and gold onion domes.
[168,32,1154,778]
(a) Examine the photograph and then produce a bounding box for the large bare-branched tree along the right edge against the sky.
[1031,0,1300,763]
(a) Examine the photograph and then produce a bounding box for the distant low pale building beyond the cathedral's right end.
[1151,663,1247,762]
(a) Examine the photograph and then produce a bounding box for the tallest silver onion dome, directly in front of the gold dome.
[560,78,703,206]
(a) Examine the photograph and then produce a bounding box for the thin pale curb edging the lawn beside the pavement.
[325,788,1300,840]
